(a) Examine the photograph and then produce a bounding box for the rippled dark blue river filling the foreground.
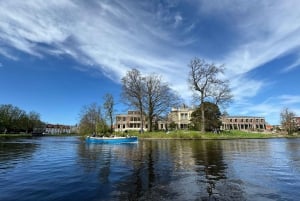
[0,137,300,201]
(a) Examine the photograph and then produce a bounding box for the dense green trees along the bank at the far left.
[0,104,44,133]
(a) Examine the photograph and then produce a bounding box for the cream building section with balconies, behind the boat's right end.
[115,111,147,131]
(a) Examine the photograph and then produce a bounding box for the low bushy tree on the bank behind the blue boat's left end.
[79,103,108,135]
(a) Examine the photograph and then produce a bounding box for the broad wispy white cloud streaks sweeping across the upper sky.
[0,0,300,122]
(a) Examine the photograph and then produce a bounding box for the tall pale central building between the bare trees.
[168,105,195,129]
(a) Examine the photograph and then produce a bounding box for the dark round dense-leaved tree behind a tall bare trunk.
[191,102,222,131]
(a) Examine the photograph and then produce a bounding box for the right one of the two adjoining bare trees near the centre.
[144,74,179,132]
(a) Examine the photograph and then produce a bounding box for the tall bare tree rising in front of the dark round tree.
[188,58,232,132]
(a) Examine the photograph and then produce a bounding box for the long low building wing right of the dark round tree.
[221,116,266,130]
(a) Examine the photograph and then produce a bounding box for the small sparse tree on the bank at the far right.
[280,108,297,134]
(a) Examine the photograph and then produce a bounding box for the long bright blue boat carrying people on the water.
[86,136,138,144]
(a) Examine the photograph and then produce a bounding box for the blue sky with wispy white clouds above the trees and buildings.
[0,0,300,124]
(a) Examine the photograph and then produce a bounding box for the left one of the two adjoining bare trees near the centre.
[122,69,145,132]
